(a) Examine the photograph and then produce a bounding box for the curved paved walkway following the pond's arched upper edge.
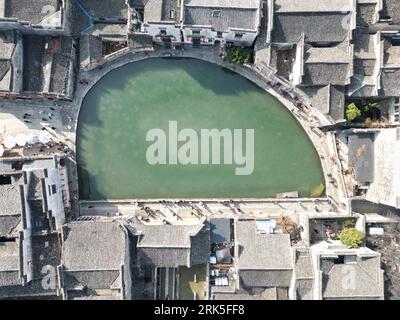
[71,48,347,211]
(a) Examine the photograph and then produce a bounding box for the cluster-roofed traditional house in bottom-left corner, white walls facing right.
[0,159,65,298]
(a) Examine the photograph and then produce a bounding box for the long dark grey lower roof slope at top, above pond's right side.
[272,13,349,43]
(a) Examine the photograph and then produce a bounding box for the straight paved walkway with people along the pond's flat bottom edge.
[81,198,338,224]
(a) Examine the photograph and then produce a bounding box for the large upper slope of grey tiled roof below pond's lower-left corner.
[62,222,125,271]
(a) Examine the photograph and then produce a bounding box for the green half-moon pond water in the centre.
[77,58,324,200]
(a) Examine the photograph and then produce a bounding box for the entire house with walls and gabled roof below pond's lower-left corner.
[58,221,131,300]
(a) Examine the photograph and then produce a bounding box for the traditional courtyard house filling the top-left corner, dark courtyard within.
[0,0,76,99]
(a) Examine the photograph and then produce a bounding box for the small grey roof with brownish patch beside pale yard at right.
[349,133,374,183]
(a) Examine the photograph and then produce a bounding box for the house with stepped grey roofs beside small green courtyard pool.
[130,221,209,300]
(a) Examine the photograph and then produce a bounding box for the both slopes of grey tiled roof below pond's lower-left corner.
[62,222,123,291]
